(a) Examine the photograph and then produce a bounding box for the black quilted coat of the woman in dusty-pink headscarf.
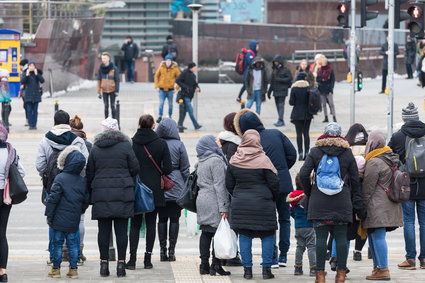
[226,165,279,237]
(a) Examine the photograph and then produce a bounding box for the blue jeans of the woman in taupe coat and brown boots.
[367,228,388,268]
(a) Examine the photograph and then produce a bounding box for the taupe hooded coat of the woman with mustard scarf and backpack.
[363,151,403,229]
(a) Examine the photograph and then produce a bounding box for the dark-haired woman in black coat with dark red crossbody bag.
[126,115,173,270]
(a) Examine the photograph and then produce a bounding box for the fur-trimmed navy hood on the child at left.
[58,145,86,175]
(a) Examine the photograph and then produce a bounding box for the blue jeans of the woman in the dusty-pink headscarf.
[239,234,275,267]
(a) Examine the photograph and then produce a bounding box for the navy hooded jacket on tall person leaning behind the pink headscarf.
[234,109,297,193]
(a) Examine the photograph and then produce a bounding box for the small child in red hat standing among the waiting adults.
[286,174,316,276]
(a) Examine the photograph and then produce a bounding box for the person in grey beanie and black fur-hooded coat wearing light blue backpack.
[299,123,366,282]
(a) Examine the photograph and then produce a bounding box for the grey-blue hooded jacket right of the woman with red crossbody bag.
[156,118,190,201]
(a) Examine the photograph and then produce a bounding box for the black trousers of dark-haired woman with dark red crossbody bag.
[130,209,158,255]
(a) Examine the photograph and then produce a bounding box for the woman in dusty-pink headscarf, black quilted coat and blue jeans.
[226,130,279,279]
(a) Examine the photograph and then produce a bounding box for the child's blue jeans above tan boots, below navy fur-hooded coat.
[52,229,80,268]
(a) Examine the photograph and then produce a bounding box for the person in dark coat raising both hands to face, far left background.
[21,62,44,130]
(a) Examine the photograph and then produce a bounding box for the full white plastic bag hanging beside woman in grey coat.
[214,218,238,259]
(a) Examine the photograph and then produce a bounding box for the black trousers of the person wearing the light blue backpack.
[314,225,348,270]
